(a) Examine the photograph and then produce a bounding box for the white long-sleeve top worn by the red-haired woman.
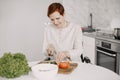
[43,23,83,60]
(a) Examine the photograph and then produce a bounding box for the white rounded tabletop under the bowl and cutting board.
[0,61,120,80]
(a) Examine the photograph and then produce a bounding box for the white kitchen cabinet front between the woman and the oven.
[83,35,96,64]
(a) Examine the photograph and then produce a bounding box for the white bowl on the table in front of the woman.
[31,64,58,80]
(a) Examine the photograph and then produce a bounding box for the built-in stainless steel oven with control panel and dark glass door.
[96,39,120,74]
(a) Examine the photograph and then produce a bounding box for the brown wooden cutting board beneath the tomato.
[58,62,78,74]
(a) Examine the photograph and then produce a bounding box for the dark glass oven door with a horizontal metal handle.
[96,47,117,72]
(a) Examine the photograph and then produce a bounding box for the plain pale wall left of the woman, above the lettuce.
[0,0,59,61]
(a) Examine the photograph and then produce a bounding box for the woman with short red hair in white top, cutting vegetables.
[43,3,83,62]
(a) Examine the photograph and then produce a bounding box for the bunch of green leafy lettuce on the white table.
[0,52,31,78]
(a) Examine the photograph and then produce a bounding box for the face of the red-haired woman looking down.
[49,11,65,28]
